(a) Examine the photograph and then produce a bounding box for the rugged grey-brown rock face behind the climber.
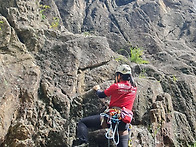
[0,0,196,147]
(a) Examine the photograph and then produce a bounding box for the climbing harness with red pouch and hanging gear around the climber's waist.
[100,107,133,146]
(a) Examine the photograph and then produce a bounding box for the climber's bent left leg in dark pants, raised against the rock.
[77,115,101,143]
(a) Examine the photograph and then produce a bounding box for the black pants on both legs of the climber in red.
[77,115,129,147]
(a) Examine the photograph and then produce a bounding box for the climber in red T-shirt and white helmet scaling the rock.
[77,64,137,147]
